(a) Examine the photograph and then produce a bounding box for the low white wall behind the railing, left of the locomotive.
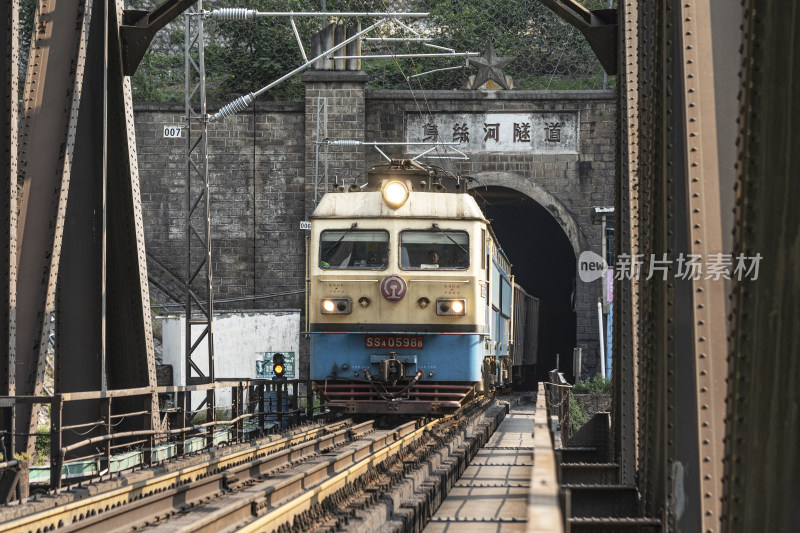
[160,310,300,408]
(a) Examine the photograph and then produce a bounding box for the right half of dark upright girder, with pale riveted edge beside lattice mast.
[106,0,161,429]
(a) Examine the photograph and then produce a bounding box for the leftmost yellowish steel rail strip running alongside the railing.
[3,421,356,533]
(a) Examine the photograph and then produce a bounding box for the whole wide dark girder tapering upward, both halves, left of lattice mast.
[55,2,158,450]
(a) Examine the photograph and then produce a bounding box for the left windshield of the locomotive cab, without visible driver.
[319,229,389,270]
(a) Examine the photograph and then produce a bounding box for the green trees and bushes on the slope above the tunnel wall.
[122,0,614,103]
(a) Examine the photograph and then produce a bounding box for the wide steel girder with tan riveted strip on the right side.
[621,0,727,531]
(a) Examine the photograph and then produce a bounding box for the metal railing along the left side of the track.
[0,379,324,501]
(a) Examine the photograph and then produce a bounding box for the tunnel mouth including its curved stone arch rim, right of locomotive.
[471,172,589,381]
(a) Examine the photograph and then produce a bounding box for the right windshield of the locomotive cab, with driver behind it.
[400,229,469,270]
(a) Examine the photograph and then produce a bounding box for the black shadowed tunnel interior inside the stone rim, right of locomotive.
[470,186,576,381]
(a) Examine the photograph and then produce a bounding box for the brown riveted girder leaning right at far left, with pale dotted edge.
[16,0,91,455]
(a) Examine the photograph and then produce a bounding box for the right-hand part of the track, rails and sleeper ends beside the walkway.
[141,400,506,533]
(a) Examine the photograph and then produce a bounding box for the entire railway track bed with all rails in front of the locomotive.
[5,400,507,533]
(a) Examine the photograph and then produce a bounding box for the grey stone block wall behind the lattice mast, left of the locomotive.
[135,103,305,309]
